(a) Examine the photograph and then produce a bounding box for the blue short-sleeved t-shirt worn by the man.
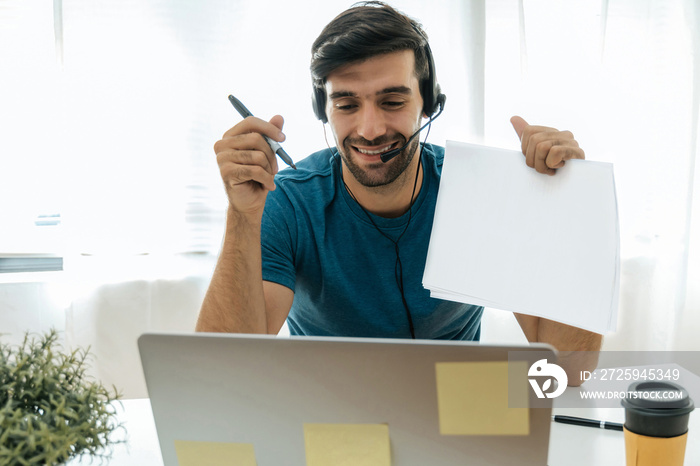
[261,144,483,340]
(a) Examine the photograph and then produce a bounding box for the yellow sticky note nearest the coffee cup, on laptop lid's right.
[435,361,530,435]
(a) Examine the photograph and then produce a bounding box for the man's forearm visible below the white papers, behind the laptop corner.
[515,314,603,386]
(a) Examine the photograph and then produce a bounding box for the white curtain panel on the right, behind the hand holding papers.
[486,0,700,350]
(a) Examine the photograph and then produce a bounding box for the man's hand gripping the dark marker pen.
[214,115,285,215]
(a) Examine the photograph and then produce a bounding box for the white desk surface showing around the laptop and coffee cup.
[70,388,700,466]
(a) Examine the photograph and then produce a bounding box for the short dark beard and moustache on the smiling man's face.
[339,135,420,188]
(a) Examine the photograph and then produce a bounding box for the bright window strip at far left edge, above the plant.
[0,0,65,272]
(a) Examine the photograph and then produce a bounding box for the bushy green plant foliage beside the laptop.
[0,330,121,466]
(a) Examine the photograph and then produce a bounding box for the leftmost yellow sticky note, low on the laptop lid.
[175,440,257,466]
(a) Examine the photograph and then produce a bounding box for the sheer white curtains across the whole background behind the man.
[0,0,700,394]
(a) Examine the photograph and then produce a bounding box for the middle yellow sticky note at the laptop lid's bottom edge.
[304,424,391,466]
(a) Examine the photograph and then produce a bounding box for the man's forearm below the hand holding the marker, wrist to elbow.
[196,209,267,333]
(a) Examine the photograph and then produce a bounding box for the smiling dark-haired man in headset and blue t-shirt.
[197,2,602,384]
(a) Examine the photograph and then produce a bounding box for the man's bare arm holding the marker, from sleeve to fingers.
[196,115,294,334]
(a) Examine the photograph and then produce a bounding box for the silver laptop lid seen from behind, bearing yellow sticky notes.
[138,334,556,466]
